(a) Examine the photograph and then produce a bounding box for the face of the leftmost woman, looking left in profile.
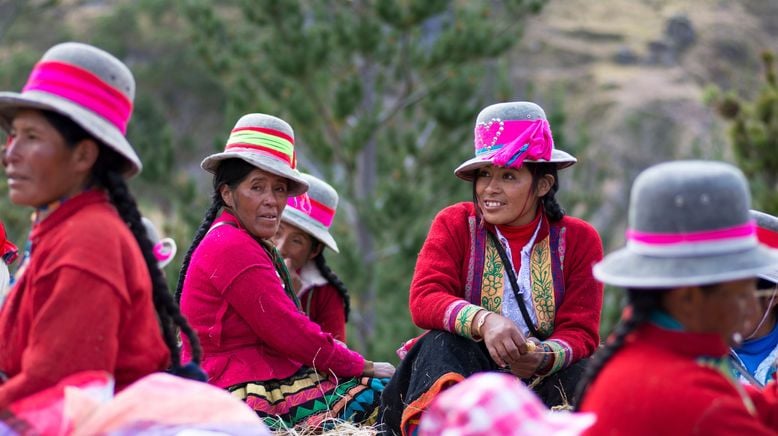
[2,110,90,207]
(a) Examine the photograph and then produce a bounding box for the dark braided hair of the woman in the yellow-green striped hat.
[176,159,255,302]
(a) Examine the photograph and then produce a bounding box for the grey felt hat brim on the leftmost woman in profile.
[0,91,143,178]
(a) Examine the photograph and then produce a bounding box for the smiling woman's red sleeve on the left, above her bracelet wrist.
[410,203,470,331]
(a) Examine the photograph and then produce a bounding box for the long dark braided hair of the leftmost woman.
[42,111,202,378]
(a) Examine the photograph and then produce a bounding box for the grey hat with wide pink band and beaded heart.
[454,101,577,181]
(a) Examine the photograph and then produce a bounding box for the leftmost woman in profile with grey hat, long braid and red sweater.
[0,43,199,408]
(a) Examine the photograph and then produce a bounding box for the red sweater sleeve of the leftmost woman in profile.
[0,267,122,408]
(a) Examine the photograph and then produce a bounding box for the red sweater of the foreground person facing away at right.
[581,324,778,436]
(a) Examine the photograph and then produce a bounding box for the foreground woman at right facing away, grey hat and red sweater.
[577,161,778,435]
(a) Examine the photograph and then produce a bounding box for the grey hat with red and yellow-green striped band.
[200,114,308,197]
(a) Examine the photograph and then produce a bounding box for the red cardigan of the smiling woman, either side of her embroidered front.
[410,202,603,365]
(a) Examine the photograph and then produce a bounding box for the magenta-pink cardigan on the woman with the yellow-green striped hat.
[181,211,365,388]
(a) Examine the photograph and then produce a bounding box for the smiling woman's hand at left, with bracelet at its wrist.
[480,313,542,368]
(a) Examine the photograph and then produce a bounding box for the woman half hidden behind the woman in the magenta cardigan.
[273,174,349,343]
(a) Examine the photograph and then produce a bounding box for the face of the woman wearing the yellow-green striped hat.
[220,169,289,239]
